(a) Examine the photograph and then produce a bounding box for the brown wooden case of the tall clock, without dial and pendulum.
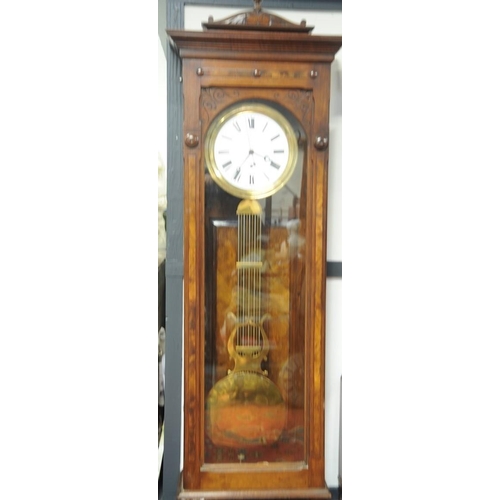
[168,2,342,499]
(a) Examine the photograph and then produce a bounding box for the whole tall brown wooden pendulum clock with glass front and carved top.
[168,2,342,499]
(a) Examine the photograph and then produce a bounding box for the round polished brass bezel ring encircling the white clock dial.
[205,101,299,200]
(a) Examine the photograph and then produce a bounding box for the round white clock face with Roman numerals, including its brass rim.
[205,103,298,199]
